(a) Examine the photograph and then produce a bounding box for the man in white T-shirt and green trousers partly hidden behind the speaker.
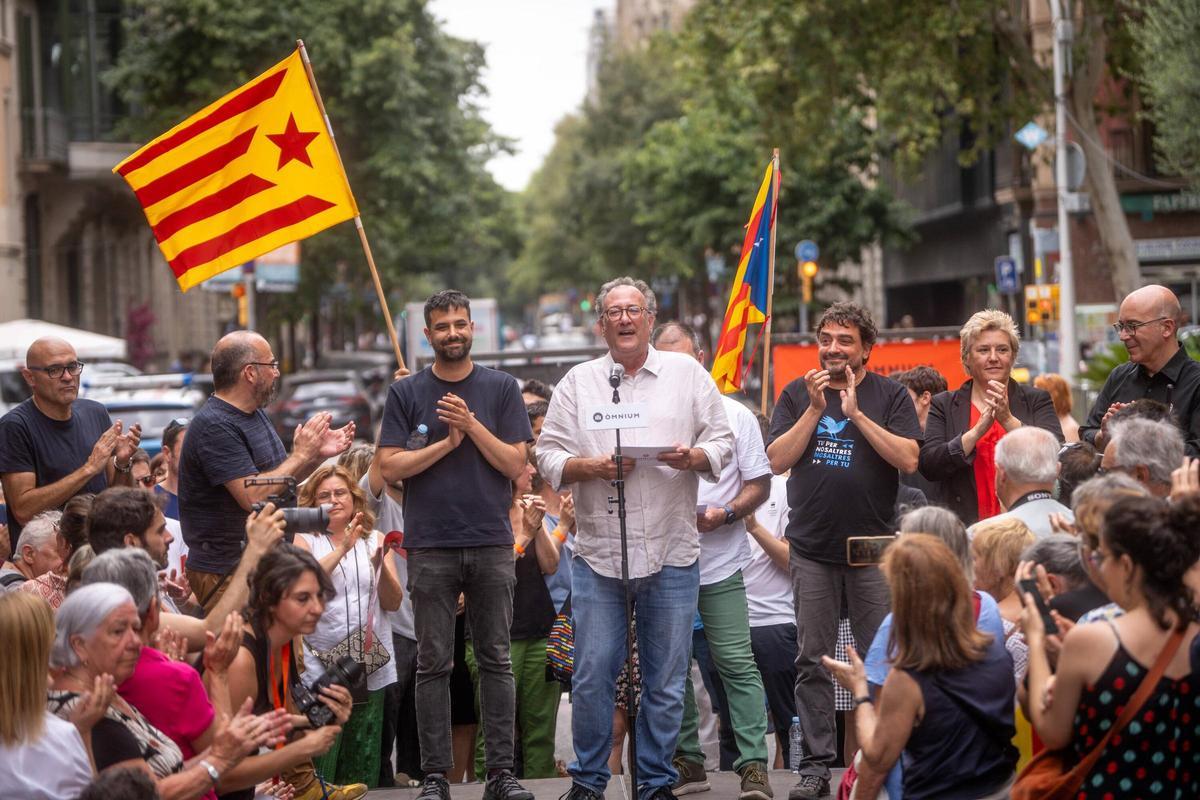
[650,321,774,800]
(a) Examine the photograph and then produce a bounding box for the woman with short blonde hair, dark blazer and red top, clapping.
[919,308,1062,525]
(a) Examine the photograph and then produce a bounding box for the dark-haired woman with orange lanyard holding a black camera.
[222,542,367,800]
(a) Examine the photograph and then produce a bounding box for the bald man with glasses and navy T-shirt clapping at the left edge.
[0,337,142,554]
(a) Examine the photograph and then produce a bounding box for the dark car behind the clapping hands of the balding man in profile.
[266,369,382,449]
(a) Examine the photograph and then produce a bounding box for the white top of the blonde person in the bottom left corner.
[0,711,91,800]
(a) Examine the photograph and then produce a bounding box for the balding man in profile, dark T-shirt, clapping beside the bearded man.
[179,331,354,610]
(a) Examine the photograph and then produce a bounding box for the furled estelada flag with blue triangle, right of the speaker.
[713,161,779,393]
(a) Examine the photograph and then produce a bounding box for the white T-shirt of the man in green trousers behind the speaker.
[696,395,770,587]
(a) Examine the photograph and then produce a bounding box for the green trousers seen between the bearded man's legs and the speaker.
[467,639,562,780]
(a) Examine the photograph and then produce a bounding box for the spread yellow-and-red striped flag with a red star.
[113,49,359,291]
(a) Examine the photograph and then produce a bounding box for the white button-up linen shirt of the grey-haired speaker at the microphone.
[538,348,733,578]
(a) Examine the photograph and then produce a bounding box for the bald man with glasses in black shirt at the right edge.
[1079,285,1200,457]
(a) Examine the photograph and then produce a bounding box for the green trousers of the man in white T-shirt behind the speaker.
[676,570,767,770]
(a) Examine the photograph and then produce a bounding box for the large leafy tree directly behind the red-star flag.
[106,0,520,328]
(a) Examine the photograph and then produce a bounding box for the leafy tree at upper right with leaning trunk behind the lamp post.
[689,0,1142,296]
